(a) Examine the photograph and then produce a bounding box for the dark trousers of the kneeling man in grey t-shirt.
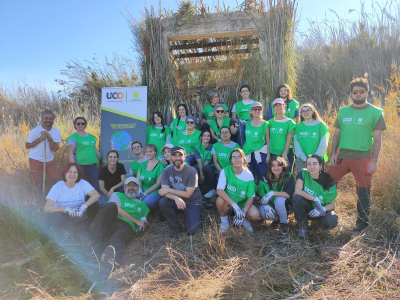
[159,197,203,235]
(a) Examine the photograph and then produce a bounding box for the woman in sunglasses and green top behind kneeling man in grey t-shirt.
[174,116,201,166]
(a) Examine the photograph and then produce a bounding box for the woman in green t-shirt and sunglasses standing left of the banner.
[65,117,100,193]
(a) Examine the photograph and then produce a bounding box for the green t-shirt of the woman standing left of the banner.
[65,132,99,165]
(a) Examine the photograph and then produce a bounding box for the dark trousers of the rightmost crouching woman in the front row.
[292,195,338,229]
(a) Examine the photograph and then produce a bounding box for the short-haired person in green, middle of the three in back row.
[232,84,254,147]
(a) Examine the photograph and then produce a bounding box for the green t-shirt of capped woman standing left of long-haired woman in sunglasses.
[269,119,296,156]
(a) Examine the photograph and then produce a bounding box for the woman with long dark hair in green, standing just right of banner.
[146,111,171,160]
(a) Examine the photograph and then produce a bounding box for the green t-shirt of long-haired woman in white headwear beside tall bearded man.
[295,122,330,162]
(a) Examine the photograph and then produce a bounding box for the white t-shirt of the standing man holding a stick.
[26,125,61,162]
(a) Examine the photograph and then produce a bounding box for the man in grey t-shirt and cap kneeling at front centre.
[158,146,203,238]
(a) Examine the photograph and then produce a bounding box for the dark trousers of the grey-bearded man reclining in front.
[92,202,135,263]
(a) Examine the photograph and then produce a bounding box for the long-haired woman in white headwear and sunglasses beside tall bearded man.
[294,103,330,173]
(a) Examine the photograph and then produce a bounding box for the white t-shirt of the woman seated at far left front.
[46,179,94,208]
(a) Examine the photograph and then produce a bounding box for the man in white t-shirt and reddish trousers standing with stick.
[25,109,61,190]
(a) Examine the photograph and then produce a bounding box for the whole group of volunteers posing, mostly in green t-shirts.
[26,78,386,278]
